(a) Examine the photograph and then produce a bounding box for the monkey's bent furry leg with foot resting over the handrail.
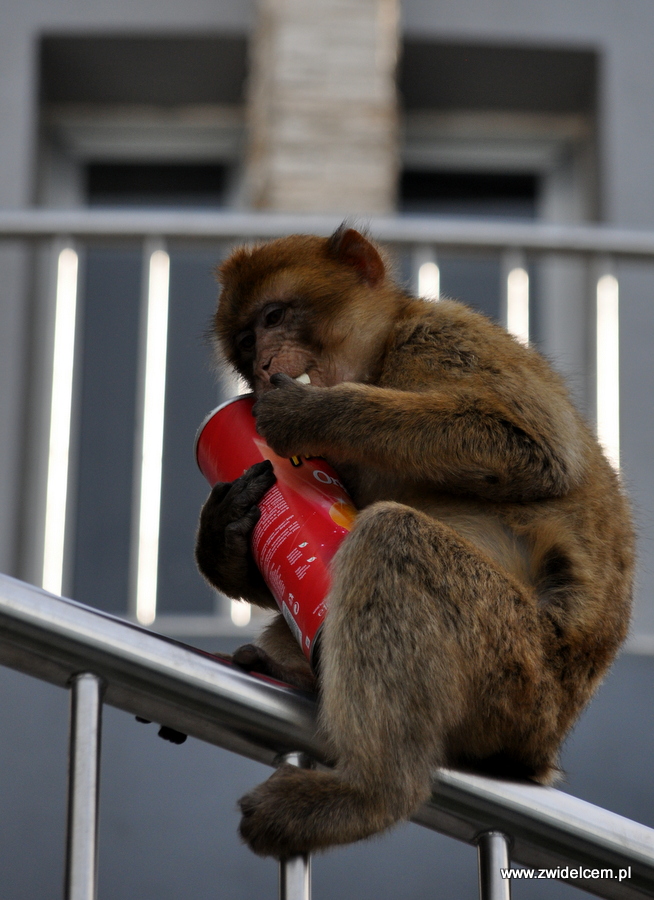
[241,503,560,857]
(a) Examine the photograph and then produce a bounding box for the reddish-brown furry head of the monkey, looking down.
[215,229,404,396]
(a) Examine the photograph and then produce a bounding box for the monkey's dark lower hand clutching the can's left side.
[195,460,276,607]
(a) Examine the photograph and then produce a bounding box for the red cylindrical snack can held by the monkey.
[195,394,357,663]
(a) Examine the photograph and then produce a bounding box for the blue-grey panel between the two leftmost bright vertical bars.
[73,248,141,613]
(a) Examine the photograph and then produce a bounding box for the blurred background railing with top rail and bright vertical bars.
[0,209,654,643]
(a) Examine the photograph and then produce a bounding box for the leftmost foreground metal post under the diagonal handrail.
[64,672,103,900]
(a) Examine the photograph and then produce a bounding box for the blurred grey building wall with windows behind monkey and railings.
[0,0,654,900]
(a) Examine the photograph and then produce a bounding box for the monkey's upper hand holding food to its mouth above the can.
[252,373,326,458]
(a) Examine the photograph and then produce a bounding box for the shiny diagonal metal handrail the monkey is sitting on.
[0,575,654,898]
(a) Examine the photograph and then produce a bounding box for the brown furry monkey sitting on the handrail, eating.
[196,226,634,857]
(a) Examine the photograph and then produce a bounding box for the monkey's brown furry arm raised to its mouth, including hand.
[254,375,584,501]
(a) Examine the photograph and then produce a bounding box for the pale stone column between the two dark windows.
[245,0,398,215]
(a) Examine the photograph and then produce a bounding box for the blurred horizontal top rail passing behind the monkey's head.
[0,208,654,260]
